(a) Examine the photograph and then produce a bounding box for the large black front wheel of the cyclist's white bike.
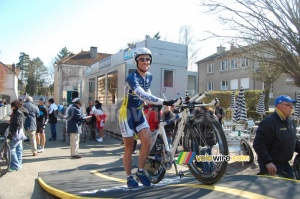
[183,112,228,185]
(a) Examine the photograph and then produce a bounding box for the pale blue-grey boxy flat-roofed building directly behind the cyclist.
[83,38,192,133]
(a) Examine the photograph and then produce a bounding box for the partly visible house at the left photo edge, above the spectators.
[0,62,19,103]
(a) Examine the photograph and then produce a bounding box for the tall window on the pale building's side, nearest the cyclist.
[107,71,118,104]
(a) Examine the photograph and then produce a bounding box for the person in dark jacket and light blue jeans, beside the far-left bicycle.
[8,100,25,172]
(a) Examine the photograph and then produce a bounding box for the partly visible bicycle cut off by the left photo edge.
[0,123,11,177]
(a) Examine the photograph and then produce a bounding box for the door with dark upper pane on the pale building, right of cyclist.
[160,69,175,100]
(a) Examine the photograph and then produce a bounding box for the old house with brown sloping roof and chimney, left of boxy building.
[54,47,110,104]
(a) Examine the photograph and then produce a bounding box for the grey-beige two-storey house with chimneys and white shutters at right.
[196,45,299,103]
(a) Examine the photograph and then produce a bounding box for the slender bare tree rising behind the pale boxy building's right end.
[179,26,200,70]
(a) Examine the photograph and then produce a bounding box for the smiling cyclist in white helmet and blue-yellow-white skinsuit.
[119,47,175,188]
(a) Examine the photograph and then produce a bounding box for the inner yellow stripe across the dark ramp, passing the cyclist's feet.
[90,170,272,199]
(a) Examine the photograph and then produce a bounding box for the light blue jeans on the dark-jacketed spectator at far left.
[9,140,23,169]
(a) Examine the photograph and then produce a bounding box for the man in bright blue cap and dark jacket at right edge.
[253,95,300,178]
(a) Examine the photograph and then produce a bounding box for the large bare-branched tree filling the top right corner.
[202,0,300,87]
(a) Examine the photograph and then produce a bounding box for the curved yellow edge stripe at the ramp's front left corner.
[38,177,115,199]
